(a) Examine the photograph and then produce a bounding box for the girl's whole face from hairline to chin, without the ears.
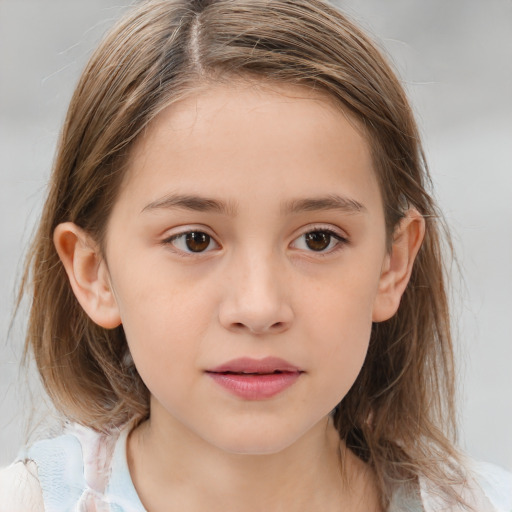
[106,84,389,453]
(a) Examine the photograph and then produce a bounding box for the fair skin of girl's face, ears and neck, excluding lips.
[54,83,424,512]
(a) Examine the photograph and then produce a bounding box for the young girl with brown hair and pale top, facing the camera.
[0,0,512,512]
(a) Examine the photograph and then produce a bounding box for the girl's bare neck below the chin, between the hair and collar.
[124,406,377,512]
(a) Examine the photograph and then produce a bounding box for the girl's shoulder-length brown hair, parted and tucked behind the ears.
[22,0,462,503]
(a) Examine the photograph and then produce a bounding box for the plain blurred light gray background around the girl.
[0,0,512,469]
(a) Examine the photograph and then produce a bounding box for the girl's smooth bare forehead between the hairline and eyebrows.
[118,83,382,226]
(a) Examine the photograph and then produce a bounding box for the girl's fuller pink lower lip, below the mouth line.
[207,372,301,400]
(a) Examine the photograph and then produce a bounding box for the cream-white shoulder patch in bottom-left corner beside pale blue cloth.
[0,461,44,512]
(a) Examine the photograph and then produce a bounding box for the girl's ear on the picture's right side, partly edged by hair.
[372,208,425,322]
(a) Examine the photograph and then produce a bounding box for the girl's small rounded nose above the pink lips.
[219,251,294,334]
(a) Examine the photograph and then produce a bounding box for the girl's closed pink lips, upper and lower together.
[206,357,304,400]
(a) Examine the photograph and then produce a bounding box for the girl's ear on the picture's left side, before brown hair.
[53,222,121,329]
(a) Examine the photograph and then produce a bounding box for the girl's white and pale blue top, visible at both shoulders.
[0,426,512,512]
